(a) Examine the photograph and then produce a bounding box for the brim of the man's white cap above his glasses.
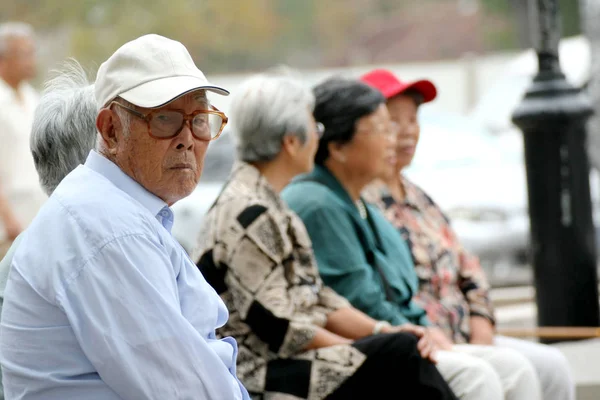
[119,76,229,108]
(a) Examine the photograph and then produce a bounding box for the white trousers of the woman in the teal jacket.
[437,345,542,400]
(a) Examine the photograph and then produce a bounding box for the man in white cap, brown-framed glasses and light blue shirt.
[0,35,249,400]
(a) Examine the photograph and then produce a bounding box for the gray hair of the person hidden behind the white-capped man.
[30,60,98,195]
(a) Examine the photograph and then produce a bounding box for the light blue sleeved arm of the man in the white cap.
[57,235,241,400]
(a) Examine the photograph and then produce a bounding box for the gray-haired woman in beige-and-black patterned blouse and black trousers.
[194,72,458,400]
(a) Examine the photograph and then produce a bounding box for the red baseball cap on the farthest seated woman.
[360,69,437,103]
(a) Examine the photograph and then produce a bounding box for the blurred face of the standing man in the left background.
[0,37,36,83]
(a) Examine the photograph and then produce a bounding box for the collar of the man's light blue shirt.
[85,150,172,227]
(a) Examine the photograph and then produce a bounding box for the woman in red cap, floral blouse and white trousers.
[361,69,575,400]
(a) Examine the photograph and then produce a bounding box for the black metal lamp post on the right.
[512,0,600,340]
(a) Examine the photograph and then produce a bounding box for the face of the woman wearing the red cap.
[387,95,420,171]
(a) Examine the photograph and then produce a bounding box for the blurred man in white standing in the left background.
[0,22,46,252]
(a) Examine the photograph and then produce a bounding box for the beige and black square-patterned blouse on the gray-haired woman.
[195,163,365,400]
